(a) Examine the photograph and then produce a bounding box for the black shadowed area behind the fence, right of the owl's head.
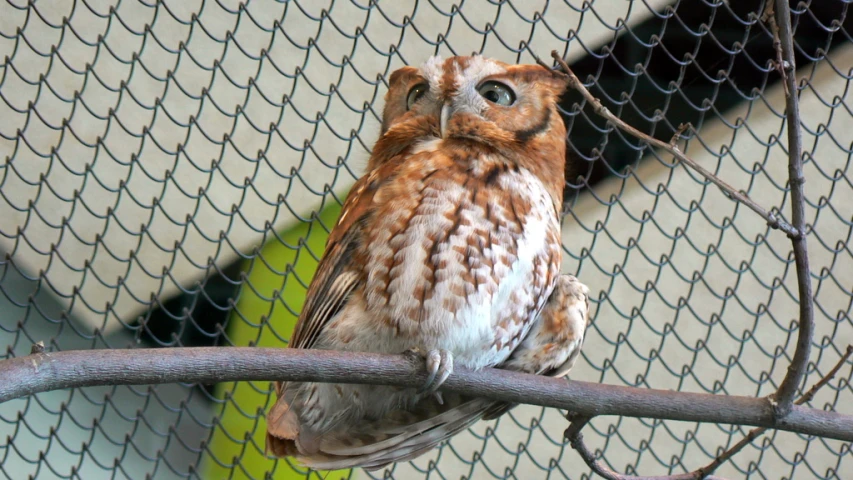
[561,0,853,200]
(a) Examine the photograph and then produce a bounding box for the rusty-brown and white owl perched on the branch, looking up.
[267,56,589,469]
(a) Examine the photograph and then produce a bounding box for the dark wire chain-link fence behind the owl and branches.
[0,0,853,479]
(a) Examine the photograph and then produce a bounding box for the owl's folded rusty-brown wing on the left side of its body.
[290,172,375,348]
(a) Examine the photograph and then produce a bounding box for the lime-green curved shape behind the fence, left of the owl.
[202,203,353,480]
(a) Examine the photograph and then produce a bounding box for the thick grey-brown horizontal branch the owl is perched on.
[0,347,853,441]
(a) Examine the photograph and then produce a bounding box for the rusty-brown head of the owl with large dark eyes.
[377,56,566,169]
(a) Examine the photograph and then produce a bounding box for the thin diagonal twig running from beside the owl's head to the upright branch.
[537,50,800,238]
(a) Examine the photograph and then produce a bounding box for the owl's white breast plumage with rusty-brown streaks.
[327,159,560,368]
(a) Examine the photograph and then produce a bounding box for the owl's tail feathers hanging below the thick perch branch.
[267,394,495,470]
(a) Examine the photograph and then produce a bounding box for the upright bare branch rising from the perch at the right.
[768,0,814,418]
